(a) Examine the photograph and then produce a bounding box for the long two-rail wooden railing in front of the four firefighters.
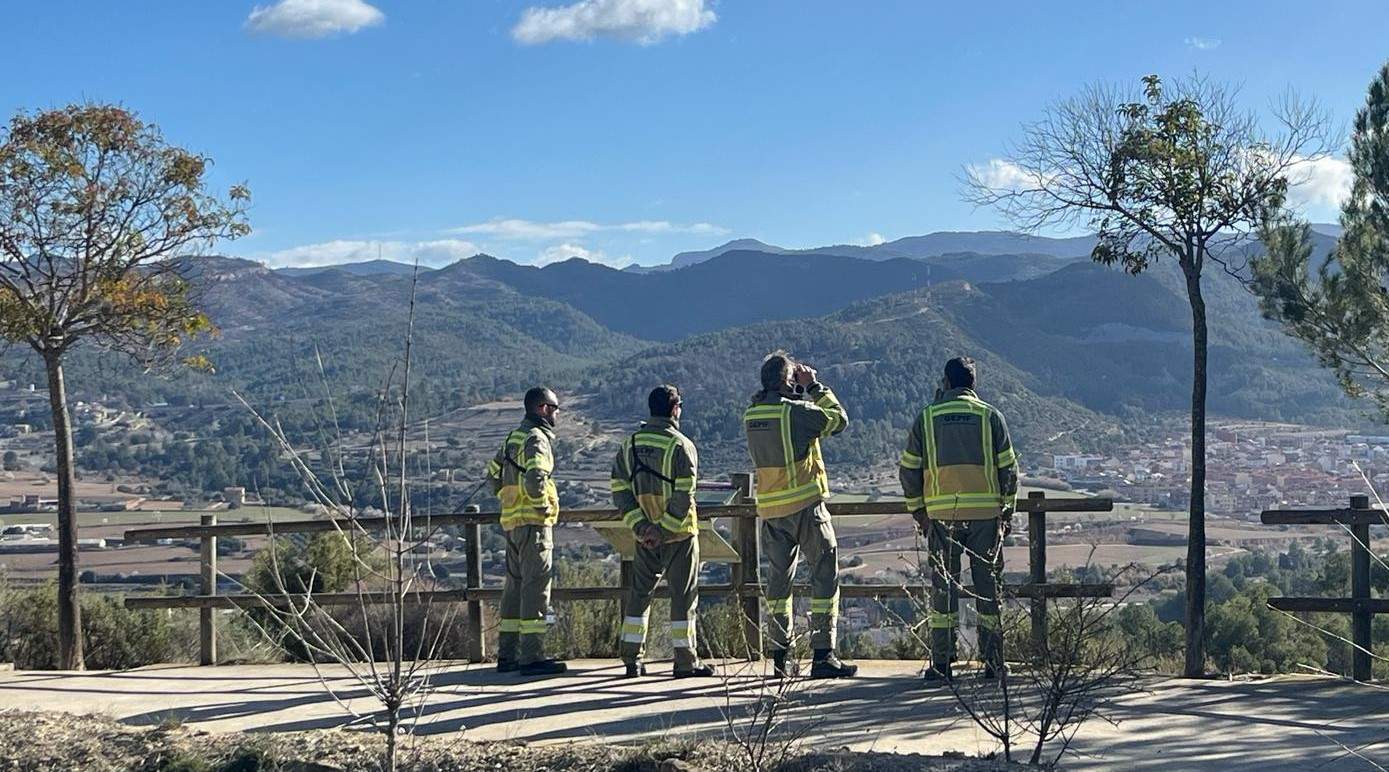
[125,475,1114,665]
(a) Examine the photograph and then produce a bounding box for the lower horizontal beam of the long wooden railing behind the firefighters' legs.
[125,585,1114,610]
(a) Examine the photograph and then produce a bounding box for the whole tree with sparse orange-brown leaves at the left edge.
[0,104,250,669]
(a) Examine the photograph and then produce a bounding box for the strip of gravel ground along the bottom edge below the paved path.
[0,712,1008,772]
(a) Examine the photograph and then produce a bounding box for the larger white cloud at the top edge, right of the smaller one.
[511,0,718,46]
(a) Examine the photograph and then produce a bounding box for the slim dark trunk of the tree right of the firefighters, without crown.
[1183,267,1207,678]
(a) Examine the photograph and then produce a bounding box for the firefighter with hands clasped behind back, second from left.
[613,386,714,678]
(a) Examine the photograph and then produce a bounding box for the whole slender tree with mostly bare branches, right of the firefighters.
[965,75,1333,678]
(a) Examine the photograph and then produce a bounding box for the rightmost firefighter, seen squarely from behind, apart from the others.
[899,357,1018,685]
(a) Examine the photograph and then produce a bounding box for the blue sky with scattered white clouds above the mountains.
[0,0,1389,265]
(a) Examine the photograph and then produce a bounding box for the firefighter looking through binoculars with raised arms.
[743,351,858,678]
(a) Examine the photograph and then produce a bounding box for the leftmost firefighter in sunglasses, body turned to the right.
[488,386,565,676]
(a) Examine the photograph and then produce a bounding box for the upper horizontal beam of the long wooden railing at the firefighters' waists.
[125,498,1114,543]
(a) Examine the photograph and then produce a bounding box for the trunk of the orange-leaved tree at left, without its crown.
[43,351,83,671]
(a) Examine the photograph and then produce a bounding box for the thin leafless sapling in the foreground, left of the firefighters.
[229,269,456,769]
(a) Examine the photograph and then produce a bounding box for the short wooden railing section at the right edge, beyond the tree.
[1258,496,1389,680]
